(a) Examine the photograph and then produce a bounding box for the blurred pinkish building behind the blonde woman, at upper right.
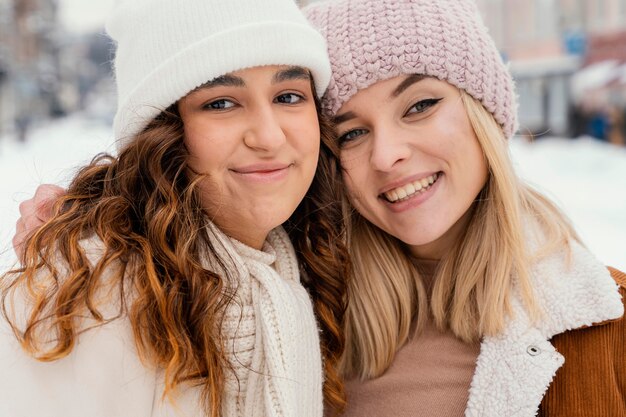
[477,0,626,137]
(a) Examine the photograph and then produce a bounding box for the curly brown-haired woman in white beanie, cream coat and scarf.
[0,0,348,417]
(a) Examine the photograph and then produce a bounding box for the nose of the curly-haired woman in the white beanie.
[243,103,287,152]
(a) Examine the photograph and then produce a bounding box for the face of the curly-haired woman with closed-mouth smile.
[178,66,320,248]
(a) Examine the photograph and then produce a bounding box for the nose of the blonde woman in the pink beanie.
[370,126,411,172]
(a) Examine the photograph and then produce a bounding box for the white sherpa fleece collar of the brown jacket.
[465,239,624,417]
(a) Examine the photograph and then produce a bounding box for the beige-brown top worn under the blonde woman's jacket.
[345,260,480,417]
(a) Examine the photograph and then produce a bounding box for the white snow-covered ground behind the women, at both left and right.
[0,117,626,270]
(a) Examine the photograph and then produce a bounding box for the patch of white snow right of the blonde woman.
[511,137,626,270]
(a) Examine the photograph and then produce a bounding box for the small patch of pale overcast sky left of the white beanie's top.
[59,0,115,32]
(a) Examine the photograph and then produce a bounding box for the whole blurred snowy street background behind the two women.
[0,0,626,269]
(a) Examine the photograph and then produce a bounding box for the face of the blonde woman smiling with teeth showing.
[335,75,487,259]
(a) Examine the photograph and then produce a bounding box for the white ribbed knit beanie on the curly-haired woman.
[106,0,330,150]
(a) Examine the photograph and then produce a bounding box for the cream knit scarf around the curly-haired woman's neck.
[204,224,323,417]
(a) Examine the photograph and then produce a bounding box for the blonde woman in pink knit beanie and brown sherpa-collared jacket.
[305,0,626,417]
